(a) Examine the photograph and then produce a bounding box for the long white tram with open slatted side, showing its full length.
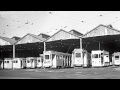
[43,51,72,68]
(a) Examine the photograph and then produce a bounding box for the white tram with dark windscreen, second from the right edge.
[91,50,110,67]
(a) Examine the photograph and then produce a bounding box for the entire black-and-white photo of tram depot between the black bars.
[0,11,120,79]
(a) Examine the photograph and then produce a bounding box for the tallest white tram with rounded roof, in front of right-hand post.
[72,49,91,67]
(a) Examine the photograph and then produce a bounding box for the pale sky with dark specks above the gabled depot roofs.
[0,11,120,38]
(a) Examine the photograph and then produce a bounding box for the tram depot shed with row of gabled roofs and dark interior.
[0,24,120,68]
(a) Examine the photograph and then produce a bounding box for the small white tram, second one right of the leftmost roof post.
[26,57,37,68]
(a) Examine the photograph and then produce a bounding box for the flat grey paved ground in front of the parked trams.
[0,66,120,79]
